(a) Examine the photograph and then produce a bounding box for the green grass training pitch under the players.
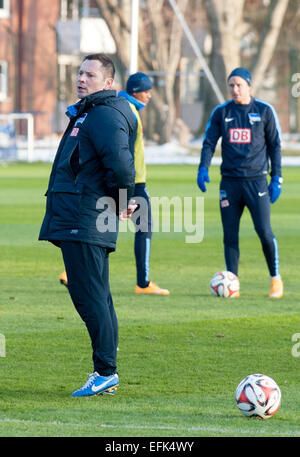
[0,163,300,437]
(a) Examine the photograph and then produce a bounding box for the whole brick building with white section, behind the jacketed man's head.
[0,0,116,137]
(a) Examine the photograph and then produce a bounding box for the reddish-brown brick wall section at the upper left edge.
[0,0,59,134]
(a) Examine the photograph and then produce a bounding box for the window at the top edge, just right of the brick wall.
[60,0,100,21]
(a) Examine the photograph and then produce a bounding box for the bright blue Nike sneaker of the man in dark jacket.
[72,371,119,397]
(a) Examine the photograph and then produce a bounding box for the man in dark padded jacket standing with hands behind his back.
[39,54,136,397]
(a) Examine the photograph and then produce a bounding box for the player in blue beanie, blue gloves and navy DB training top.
[197,67,283,298]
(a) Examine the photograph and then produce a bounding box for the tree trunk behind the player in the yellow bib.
[96,0,188,143]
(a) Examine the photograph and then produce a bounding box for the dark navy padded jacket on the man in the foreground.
[39,90,136,250]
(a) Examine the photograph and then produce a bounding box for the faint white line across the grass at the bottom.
[0,418,300,437]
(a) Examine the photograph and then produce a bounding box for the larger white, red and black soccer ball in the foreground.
[235,374,281,419]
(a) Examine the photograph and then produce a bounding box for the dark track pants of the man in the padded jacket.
[60,241,118,376]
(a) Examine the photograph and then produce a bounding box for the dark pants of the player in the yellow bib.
[132,183,152,287]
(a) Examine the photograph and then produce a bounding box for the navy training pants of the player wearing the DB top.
[220,177,279,276]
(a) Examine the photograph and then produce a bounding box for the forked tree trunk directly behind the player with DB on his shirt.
[202,0,290,130]
